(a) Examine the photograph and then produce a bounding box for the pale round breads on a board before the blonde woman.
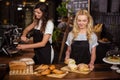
[61,59,90,74]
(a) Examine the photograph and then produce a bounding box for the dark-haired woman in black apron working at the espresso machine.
[17,2,54,64]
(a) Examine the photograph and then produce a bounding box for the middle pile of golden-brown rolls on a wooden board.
[34,64,68,78]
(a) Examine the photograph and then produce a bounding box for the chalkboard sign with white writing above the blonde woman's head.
[64,0,90,13]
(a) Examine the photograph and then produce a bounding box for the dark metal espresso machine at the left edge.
[0,25,22,56]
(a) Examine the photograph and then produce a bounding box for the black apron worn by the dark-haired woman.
[33,29,51,64]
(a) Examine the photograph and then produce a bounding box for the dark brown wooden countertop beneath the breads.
[4,64,120,80]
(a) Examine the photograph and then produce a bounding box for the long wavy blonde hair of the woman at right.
[72,10,93,41]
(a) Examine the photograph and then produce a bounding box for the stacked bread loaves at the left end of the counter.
[9,58,34,75]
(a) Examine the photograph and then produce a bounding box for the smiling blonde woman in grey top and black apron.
[65,10,98,70]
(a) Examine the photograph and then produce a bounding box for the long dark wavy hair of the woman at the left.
[34,2,49,32]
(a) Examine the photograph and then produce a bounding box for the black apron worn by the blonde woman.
[70,41,91,64]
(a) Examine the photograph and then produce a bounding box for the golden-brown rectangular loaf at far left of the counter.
[9,61,27,70]
